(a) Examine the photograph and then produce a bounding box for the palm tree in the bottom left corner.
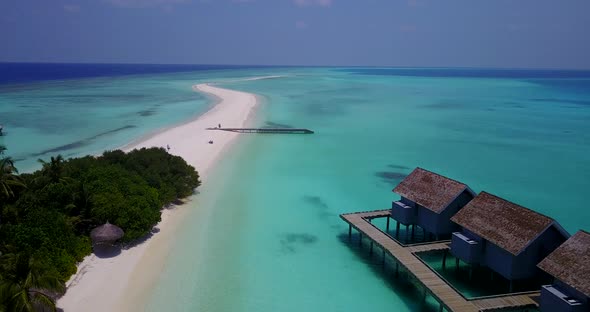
[0,254,65,312]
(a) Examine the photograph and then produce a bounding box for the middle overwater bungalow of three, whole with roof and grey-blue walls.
[451,192,569,292]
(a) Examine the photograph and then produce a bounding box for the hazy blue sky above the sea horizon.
[0,0,590,69]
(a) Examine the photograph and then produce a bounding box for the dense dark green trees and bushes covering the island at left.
[0,148,200,312]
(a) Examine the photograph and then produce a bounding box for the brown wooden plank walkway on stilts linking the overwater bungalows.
[340,209,538,312]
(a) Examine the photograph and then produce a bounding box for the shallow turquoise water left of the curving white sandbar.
[0,64,294,172]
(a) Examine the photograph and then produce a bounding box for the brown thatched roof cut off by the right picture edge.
[537,231,590,297]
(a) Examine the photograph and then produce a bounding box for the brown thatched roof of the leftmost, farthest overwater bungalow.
[393,167,467,213]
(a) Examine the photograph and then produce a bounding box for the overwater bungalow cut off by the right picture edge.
[538,231,590,312]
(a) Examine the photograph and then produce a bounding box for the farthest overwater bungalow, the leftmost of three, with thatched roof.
[391,168,475,239]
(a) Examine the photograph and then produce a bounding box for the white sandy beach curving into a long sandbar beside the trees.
[58,81,264,312]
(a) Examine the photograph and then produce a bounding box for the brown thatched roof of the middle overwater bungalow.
[451,192,555,256]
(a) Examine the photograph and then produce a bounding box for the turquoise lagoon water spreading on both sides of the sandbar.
[0,68,590,311]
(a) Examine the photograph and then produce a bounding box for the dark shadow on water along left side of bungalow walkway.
[338,233,439,312]
